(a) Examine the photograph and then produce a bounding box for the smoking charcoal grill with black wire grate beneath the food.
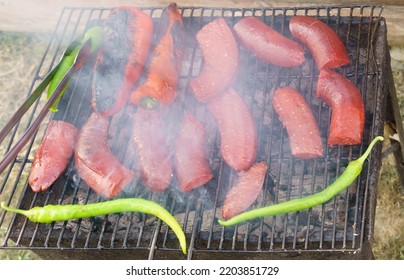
[0,5,392,259]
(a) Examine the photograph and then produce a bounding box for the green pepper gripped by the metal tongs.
[48,26,103,112]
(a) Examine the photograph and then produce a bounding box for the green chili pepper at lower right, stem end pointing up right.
[219,136,383,226]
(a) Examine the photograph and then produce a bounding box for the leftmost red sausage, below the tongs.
[28,120,78,192]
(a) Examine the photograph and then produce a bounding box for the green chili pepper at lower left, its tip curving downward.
[0,198,187,254]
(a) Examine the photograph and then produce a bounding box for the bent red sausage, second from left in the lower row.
[74,113,133,198]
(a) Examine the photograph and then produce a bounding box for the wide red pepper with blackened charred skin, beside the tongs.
[92,6,153,116]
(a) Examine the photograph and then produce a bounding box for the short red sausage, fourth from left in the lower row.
[174,113,213,192]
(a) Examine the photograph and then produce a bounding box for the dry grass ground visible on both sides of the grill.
[0,32,404,260]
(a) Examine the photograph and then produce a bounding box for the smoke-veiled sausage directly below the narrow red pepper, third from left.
[133,107,173,192]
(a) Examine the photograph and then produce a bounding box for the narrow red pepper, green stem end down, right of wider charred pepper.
[131,3,185,106]
